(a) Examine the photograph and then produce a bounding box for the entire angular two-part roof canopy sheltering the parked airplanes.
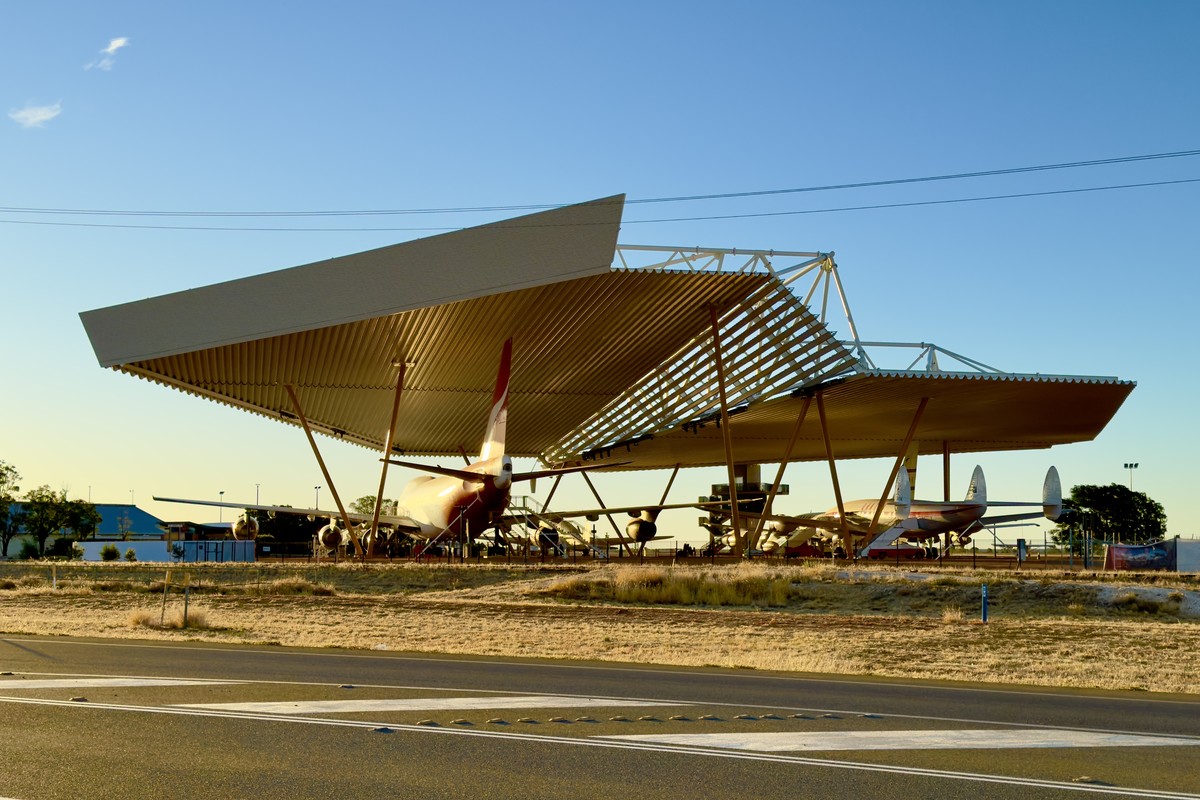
[80,197,1133,469]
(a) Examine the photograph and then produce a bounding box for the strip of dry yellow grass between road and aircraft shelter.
[0,565,1200,693]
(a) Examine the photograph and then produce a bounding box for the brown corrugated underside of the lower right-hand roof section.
[576,372,1135,469]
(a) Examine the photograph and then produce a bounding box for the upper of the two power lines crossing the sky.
[0,150,1200,220]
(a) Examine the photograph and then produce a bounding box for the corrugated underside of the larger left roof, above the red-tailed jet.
[118,271,770,456]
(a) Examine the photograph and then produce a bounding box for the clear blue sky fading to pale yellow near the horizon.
[0,1,1200,539]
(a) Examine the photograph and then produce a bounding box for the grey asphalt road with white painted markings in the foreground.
[0,632,1200,800]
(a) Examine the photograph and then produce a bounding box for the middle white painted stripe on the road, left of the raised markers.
[175,694,679,714]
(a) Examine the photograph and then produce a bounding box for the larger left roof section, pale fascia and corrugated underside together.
[82,197,768,456]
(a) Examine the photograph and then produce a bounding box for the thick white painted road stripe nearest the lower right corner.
[600,729,1200,753]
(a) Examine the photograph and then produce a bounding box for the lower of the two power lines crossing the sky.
[0,178,1200,233]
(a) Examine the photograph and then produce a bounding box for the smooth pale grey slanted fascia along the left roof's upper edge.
[79,194,625,367]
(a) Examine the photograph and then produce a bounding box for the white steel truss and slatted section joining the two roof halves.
[542,245,1116,463]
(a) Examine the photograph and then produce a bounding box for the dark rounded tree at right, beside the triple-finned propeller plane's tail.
[1052,483,1166,549]
